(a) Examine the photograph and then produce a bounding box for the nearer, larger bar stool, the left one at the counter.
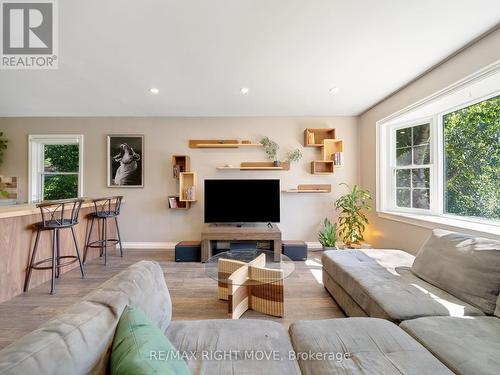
[24,199,87,294]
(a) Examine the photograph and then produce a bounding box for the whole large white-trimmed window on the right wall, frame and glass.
[377,67,500,225]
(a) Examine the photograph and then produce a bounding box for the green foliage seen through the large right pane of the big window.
[443,96,500,219]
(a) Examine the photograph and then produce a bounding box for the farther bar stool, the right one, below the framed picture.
[83,196,123,265]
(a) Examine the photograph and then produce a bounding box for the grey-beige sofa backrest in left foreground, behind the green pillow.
[0,261,171,375]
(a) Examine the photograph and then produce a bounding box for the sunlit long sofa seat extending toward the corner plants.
[322,249,484,323]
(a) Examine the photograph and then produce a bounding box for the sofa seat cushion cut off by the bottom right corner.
[401,316,500,375]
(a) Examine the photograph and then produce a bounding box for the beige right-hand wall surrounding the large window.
[359,30,500,253]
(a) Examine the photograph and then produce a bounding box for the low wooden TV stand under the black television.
[201,224,281,262]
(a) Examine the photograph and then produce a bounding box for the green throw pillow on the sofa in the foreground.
[111,306,190,375]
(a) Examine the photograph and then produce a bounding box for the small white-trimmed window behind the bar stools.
[29,134,83,202]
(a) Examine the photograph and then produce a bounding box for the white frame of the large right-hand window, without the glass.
[376,62,500,234]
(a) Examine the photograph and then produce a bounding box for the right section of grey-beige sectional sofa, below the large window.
[322,230,500,375]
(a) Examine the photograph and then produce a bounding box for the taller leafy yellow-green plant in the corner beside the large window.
[335,183,372,248]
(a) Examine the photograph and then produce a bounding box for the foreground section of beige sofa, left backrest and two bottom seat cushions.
[0,261,451,375]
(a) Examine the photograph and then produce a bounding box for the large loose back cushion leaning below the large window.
[411,229,500,314]
